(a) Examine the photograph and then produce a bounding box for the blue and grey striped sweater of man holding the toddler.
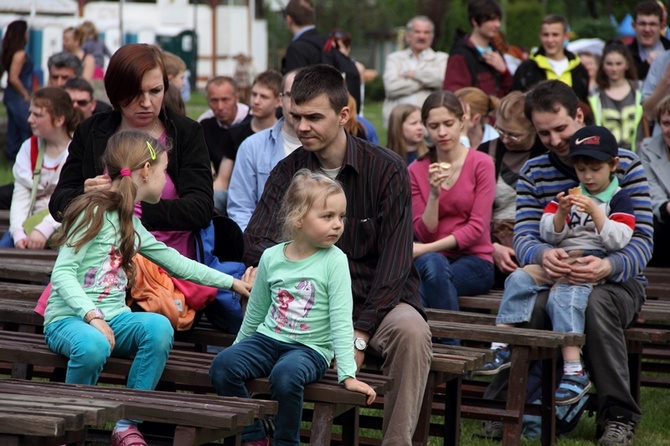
[514,149,654,284]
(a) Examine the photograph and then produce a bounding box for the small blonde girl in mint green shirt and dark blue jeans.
[210,169,376,446]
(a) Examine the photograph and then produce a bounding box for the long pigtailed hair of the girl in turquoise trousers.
[52,130,167,285]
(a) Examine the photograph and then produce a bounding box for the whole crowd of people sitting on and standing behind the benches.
[0,0,670,446]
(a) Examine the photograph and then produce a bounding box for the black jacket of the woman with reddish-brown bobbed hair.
[49,109,214,231]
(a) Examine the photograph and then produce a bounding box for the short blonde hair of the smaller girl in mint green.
[279,169,344,240]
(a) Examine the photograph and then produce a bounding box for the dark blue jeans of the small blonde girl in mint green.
[209,333,329,446]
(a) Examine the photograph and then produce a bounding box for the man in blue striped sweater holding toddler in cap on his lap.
[486,80,653,445]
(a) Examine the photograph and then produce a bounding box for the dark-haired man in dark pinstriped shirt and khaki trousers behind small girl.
[244,64,432,446]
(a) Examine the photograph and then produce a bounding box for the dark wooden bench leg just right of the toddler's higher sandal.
[502,345,530,446]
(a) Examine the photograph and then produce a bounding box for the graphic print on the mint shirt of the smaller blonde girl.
[271,280,316,338]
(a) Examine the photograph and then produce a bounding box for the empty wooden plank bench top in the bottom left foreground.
[0,379,277,446]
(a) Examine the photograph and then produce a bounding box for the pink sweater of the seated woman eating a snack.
[409,149,496,262]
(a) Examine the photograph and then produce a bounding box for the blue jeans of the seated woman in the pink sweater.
[414,252,494,310]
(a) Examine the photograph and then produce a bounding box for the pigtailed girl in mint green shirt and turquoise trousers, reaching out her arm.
[44,131,250,446]
